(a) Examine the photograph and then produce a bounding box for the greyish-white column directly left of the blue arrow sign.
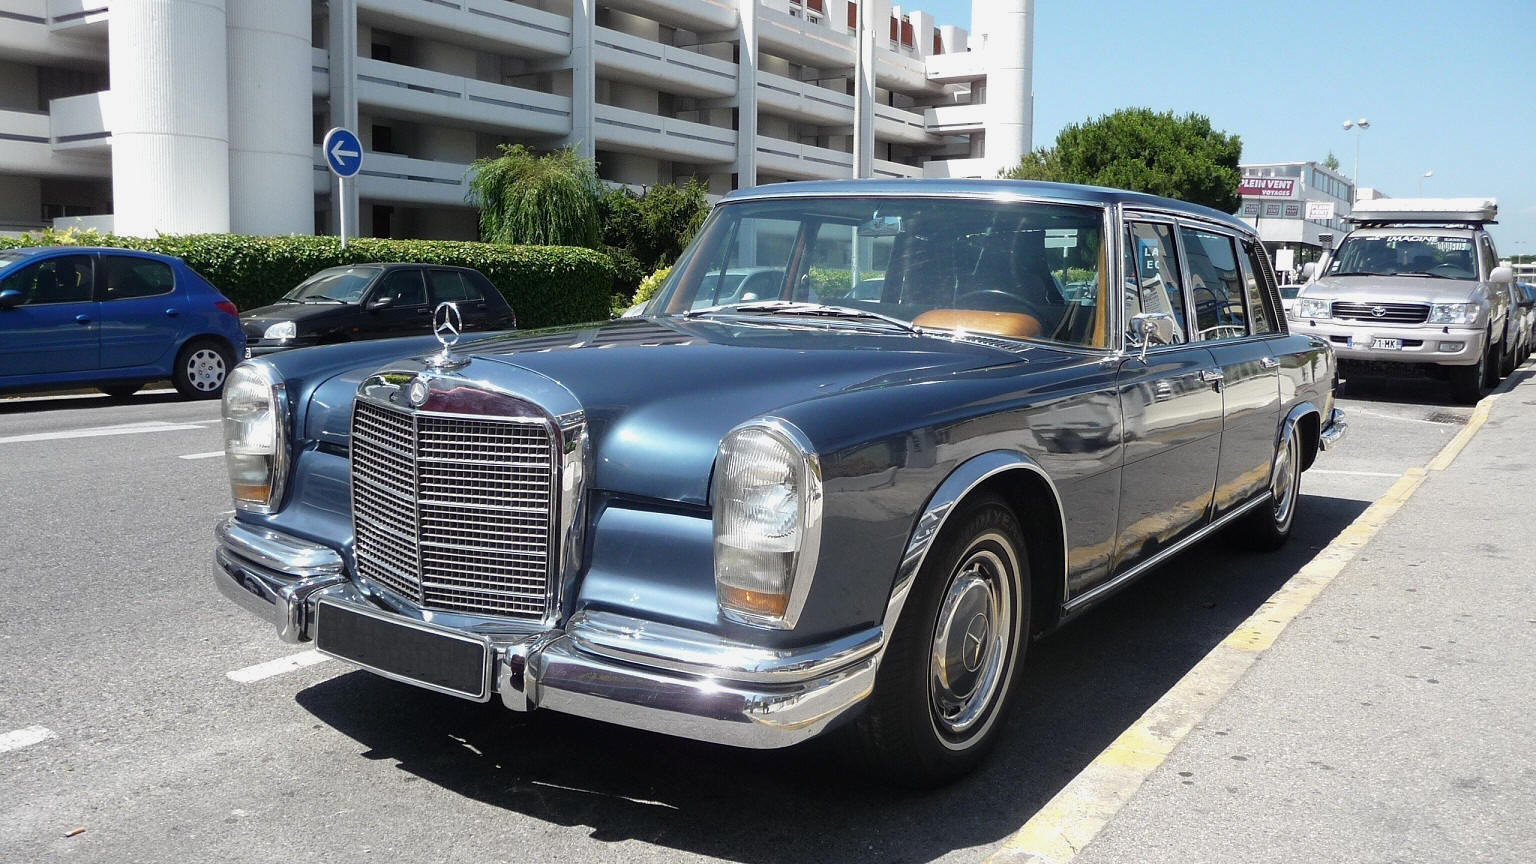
[226,0,315,234]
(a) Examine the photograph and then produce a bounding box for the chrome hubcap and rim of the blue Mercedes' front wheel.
[928,533,1017,738]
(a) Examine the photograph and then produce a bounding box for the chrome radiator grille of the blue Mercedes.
[352,400,556,620]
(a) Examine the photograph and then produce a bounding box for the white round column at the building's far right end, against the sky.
[983,0,1035,175]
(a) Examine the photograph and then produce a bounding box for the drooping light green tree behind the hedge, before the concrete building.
[467,145,602,248]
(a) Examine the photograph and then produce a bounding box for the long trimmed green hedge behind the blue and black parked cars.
[0,231,614,327]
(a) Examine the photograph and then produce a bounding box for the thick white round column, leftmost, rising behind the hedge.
[108,0,229,237]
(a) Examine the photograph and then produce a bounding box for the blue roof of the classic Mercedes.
[722,178,1253,234]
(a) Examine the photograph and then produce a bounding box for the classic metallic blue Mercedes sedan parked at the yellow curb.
[214,181,1344,784]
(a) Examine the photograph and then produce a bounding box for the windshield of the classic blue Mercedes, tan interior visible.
[651,197,1109,347]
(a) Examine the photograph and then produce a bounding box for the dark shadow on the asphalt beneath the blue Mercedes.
[296,495,1369,864]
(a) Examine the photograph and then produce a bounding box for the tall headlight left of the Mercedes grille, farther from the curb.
[223,363,287,513]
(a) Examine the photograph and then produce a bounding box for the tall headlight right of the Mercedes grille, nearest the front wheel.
[711,420,822,629]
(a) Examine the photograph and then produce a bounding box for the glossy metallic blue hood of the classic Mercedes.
[307,318,1032,504]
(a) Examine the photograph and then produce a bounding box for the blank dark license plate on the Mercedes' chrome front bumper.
[315,598,492,701]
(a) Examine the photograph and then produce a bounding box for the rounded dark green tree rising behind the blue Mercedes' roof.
[1001,108,1243,212]
